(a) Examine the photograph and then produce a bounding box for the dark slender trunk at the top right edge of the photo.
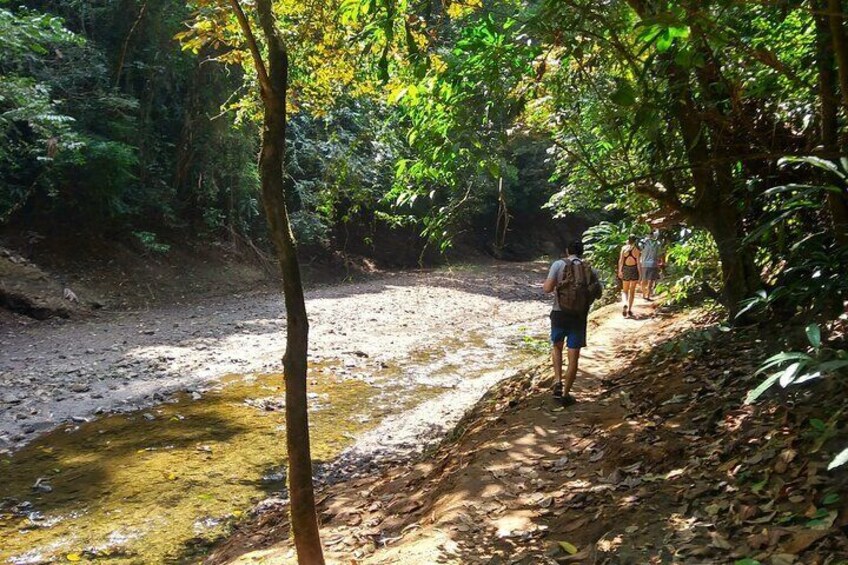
[813,0,848,246]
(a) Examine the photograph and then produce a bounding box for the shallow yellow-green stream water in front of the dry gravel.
[0,332,531,565]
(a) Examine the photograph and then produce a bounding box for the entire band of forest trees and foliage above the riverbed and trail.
[0,0,848,318]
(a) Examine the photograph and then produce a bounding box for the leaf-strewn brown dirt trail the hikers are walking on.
[213,303,663,563]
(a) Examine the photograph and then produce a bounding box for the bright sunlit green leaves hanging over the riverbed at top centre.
[386,10,538,250]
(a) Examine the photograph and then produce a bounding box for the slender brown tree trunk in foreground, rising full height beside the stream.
[231,0,324,565]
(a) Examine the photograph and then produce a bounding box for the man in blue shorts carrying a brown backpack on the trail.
[542,239,603,405]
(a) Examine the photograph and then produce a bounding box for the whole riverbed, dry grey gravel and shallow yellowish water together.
[0,263,547,563]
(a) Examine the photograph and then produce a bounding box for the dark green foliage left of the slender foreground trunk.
[0,0,258,239]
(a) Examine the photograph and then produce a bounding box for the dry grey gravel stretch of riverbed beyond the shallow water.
[0,263,546,452]
